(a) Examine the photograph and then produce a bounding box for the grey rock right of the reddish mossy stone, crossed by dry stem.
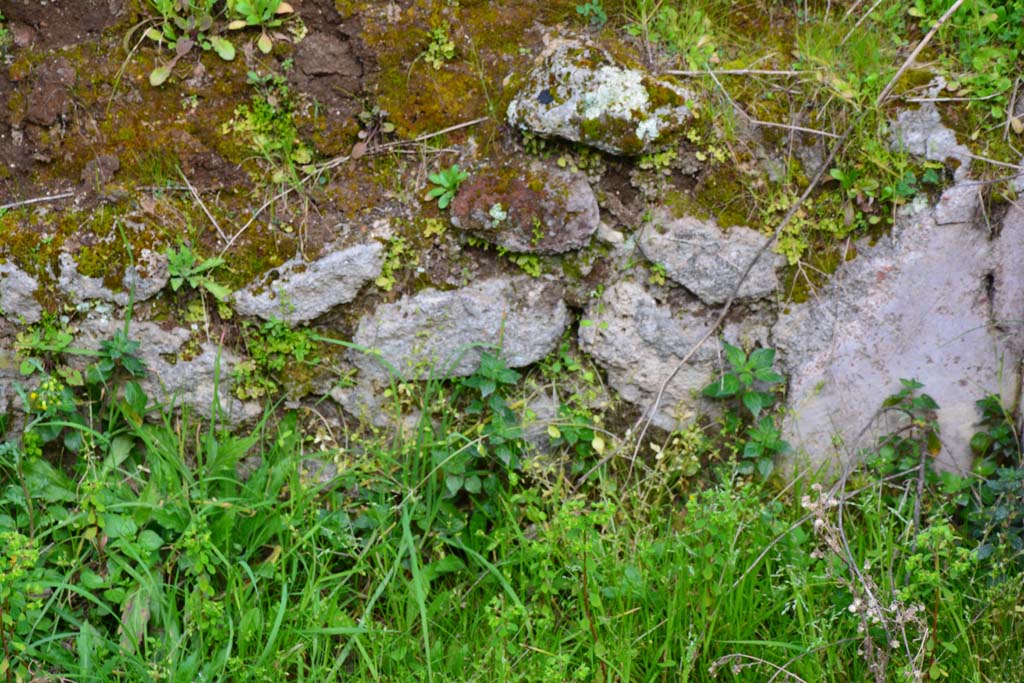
[639,210,784,304]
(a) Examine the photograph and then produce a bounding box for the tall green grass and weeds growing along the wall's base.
[0,337,1024,683]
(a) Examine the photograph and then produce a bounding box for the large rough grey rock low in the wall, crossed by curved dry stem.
[580,280,768,430]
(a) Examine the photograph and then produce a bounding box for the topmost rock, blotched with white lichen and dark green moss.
[508,41,690,156]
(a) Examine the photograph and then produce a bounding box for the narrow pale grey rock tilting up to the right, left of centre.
[234,242,384,325]
